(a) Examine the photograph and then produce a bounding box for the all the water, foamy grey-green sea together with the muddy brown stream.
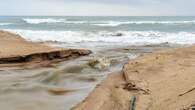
[0,16,195,110]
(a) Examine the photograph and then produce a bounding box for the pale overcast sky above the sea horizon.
[0,0,195,16]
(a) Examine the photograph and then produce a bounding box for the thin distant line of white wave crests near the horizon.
[23,18,195,27]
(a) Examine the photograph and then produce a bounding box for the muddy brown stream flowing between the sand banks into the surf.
[0,44,181,110]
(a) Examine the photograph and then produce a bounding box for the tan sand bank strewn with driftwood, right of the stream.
[73,46,195,110]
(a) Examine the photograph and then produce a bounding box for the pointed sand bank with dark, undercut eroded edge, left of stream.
[0,31,91,66]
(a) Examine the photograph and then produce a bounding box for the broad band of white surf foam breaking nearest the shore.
[4,30,195,45]
